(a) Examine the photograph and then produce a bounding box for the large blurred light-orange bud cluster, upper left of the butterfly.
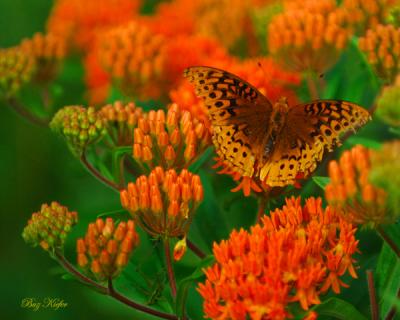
[99,22,164,98]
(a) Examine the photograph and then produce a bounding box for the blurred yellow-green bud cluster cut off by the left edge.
[0,47,36,98]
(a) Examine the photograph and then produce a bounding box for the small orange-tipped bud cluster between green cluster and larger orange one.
[100,101,143,146]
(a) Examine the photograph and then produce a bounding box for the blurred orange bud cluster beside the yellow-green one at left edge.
[20,33,67,83]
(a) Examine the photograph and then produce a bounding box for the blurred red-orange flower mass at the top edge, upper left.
[47,0,141,50]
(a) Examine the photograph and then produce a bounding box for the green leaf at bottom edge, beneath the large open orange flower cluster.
[312,298,367,320]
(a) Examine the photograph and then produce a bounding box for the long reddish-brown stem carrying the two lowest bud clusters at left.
[55,251,178,320]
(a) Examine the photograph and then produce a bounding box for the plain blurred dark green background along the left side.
[0,0,148,320]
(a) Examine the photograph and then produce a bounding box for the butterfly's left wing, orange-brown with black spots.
[184,67,272,176]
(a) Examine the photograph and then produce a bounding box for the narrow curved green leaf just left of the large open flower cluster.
[175,256,214,318]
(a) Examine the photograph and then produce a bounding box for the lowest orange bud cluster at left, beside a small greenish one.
[76,218,139,281]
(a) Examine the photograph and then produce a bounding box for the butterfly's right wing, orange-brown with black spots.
[260,100,370,186]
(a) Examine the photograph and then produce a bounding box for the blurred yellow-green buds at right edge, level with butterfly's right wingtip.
[375,76,400,127]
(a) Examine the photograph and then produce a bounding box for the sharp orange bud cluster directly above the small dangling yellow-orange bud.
[120,167,203,237]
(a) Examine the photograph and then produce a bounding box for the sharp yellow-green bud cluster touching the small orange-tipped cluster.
[50,106,106,155]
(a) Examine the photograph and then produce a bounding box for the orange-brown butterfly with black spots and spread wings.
[184,67,370,187]
